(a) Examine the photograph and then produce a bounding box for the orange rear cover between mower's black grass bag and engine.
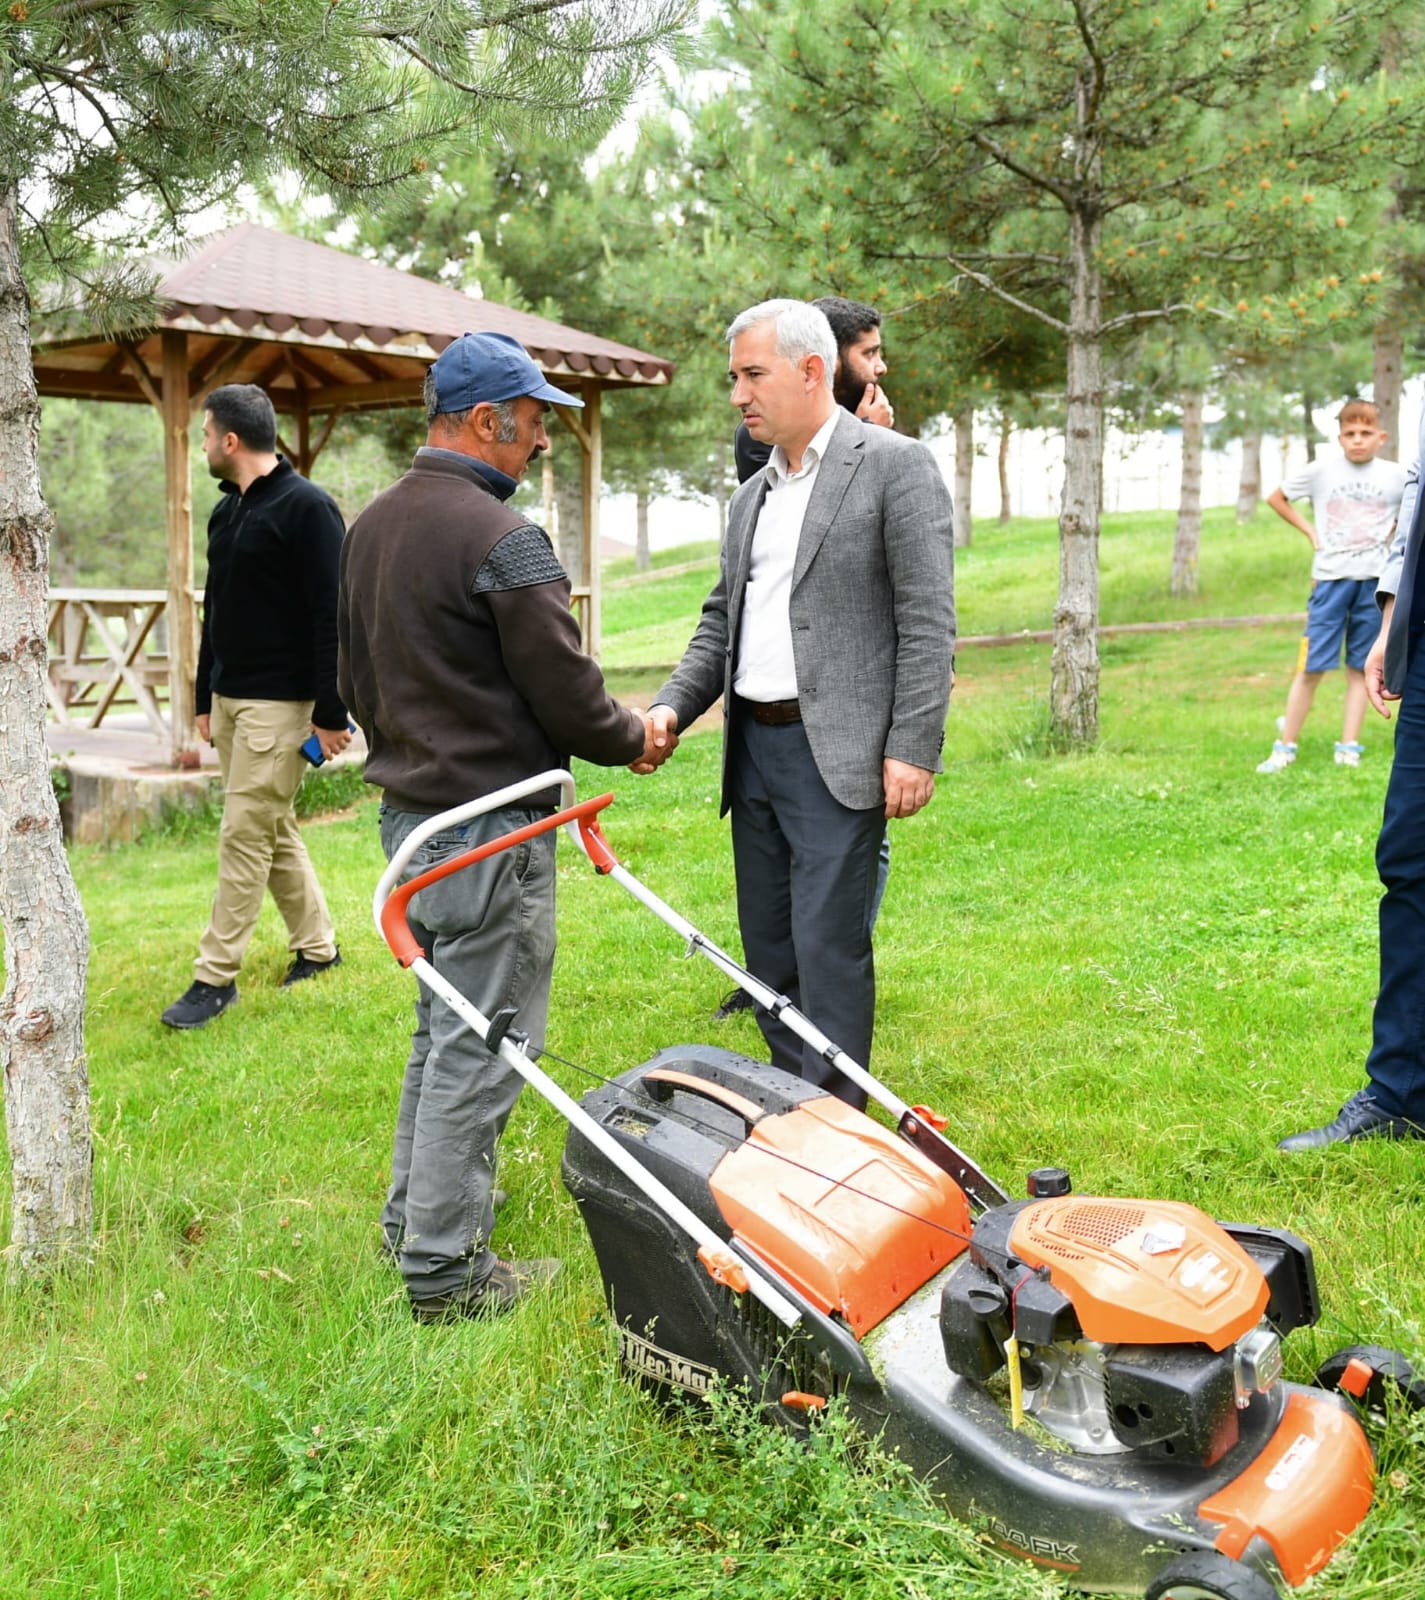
[710,1094,971,1338]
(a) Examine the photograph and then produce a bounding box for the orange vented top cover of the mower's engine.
[1009,1195,1270,1350]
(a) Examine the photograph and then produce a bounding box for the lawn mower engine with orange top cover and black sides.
[940,1170,1318,1466]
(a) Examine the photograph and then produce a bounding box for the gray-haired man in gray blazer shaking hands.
[635,299,955,1104]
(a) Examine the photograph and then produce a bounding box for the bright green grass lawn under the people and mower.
[0,517,1425,1600]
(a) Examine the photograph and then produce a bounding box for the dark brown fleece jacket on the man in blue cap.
[337,453,643,813]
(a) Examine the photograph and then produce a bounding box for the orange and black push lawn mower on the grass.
[374,771,1425,1600]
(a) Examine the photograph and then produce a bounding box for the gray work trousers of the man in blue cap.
[381,806,555,1299]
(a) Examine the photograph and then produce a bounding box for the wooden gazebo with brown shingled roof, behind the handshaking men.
[34,222,673,758]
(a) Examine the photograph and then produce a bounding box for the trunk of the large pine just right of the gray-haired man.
[1049,204,1104,749]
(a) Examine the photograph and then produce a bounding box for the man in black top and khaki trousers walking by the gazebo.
[163,384,350,1027]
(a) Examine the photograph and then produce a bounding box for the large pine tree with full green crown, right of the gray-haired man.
[713,0,1422,747]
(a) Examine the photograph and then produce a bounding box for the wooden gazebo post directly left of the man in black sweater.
[160,328,198,766]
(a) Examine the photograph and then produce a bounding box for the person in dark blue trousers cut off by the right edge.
[1279,400,1425,1150]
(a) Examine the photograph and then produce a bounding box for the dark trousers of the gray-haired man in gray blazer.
[729,715,886,1106]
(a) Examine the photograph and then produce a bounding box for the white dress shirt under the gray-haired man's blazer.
[732,406,841,701]
